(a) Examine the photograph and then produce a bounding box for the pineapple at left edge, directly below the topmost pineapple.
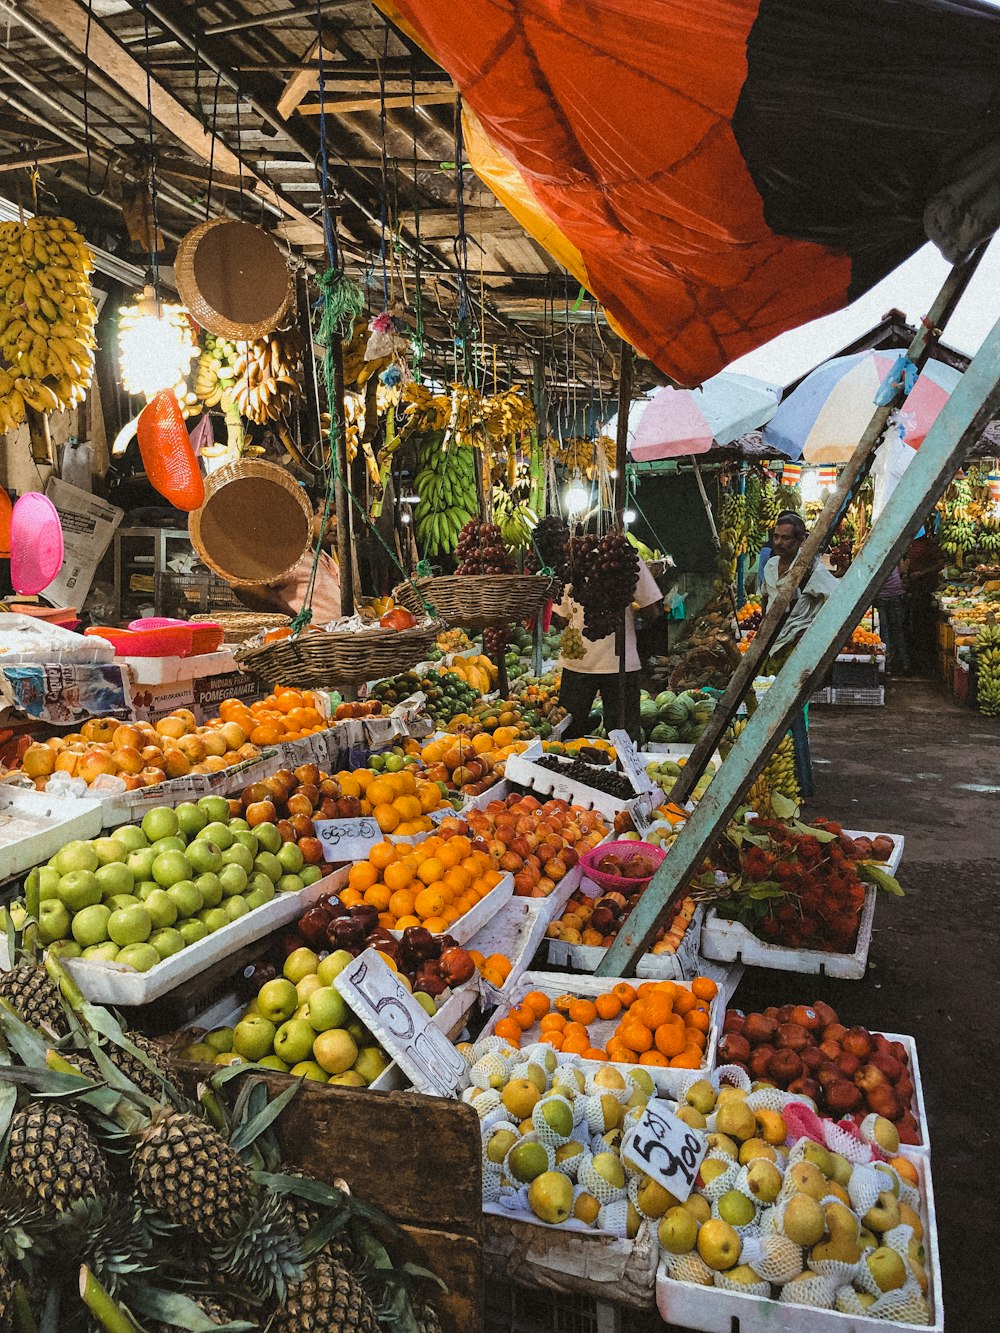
[7,1102,112,1212]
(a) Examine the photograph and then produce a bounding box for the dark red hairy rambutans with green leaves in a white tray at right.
[692,818,903,953]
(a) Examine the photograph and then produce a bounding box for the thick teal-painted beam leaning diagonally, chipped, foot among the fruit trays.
[597,311,1000,977]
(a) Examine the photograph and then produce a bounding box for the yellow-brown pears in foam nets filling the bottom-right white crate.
[656,1080,931,1326]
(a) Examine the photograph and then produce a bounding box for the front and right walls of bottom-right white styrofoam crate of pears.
[656,1154,944,1333]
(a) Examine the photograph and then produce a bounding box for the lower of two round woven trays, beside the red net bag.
[188,459,312,588]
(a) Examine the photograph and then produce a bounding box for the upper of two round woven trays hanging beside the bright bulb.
[173,217,295,343]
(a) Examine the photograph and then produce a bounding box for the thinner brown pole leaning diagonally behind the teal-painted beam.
[671,248,984,802]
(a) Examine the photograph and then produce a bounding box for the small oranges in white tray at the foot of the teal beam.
[491,977,717,1069]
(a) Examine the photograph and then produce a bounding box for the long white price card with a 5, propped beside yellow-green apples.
[333,949,469,1097]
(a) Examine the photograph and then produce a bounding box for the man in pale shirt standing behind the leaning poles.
[760,511,837,797]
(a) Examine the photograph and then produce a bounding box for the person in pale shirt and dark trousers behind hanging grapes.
[552,560,663,740]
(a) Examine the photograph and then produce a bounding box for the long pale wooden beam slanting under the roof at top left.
[32,0,323,239]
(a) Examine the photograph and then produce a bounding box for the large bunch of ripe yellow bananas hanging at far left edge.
[0,217,97,431]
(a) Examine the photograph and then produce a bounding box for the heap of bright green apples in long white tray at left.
[12,796,323,972]
